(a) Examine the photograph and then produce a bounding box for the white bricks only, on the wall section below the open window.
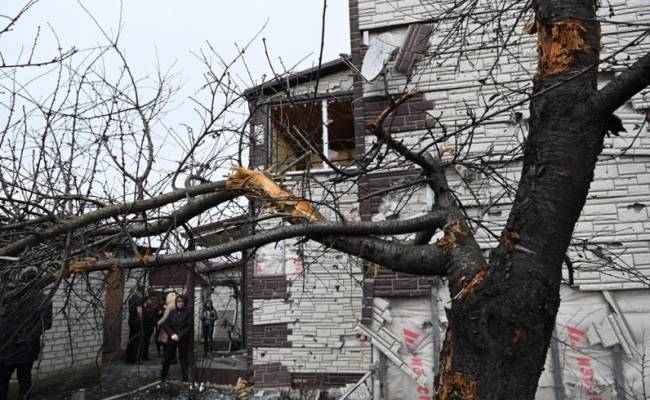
[253,177,370,373]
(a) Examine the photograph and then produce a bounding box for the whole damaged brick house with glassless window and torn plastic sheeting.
[194,0,650,399]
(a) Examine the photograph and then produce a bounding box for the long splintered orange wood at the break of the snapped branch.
[226,167,323,223]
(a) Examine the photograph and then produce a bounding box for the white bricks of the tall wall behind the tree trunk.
[359,0,650,290]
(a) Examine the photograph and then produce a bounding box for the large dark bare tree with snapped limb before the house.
[0,0,650,399]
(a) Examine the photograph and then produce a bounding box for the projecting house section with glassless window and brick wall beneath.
[235,50,441,388]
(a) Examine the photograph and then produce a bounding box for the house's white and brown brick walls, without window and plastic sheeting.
[242,0,650,385]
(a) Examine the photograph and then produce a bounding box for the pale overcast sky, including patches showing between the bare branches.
[0,0,350,184]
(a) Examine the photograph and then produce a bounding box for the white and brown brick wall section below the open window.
[243,176,370,387]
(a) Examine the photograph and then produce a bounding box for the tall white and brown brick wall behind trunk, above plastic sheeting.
[350,0,650,290]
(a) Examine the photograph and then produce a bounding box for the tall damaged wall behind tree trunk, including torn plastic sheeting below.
[350,0,650,400]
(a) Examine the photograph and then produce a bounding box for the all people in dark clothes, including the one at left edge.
[0,276,217,400]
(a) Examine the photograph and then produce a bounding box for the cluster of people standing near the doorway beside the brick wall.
[126,286,217,381]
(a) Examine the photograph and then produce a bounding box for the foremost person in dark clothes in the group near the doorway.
[160,296,193,382]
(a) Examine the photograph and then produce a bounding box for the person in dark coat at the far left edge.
[0,267,52,400]
